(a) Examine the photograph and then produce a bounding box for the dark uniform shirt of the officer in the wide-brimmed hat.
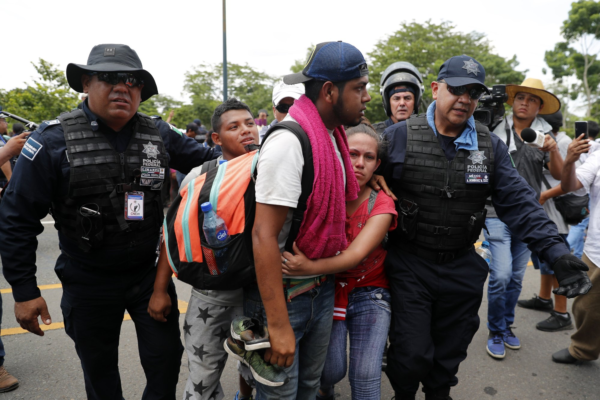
[0,101,220,301]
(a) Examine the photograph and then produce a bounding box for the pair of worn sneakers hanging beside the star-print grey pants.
[223,317,290,387]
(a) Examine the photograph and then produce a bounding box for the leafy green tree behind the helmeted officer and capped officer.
[366,21,527,122]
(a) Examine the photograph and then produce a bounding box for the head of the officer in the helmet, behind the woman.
[373,61,423,135]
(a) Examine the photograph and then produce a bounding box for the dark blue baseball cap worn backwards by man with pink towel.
[283,41,369,85]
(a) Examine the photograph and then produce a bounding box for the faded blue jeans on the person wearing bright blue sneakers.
[484,218,531,332]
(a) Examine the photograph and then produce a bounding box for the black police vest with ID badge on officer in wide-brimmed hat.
[52,110,168,251]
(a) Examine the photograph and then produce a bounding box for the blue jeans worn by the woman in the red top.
[321,286,392,400]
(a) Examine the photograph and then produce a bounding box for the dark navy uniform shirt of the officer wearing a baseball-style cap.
[381,121,569,265]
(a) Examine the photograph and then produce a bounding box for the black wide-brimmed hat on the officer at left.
[67,44,158,101]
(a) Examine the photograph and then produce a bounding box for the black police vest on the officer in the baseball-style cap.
[392,115,494,263]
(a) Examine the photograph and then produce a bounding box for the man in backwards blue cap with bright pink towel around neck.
[239,42,371,400]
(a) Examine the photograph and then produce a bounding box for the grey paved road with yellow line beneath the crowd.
[0,220,600,400]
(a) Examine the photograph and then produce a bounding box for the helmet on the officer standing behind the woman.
[379,61,423,117]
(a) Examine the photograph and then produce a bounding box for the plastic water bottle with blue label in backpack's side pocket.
[200,202,229,275]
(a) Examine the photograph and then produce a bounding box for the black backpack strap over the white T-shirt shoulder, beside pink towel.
[261,121,315,253]
